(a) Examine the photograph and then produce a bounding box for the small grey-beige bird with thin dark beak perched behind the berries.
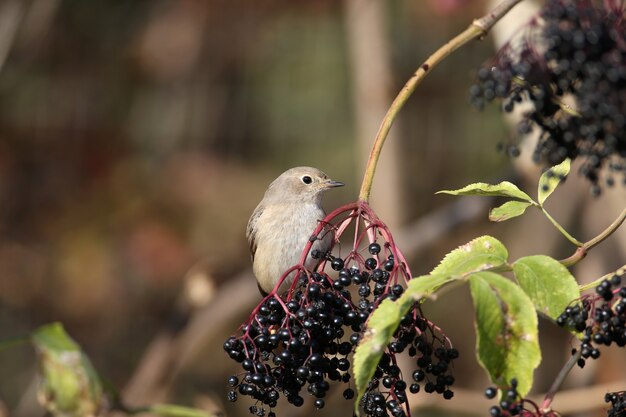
[246,167,344,296]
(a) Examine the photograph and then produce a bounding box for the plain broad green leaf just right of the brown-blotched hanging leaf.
[513,255,580,320]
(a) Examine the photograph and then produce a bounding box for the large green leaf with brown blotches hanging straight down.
[469,272,541,396]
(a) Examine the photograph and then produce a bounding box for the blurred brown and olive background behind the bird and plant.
[0,0,626,417]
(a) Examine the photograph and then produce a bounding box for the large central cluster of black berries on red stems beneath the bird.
[224,202,458,417]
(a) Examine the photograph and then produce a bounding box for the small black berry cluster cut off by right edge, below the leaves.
[556,274,626,368]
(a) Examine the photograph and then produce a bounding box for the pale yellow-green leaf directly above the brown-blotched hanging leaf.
[431,236,509,276]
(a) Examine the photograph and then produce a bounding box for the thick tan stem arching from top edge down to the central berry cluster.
[359,0,522,201]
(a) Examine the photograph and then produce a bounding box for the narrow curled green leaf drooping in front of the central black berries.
[353,275,456,414]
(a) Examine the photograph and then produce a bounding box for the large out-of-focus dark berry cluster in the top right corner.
[470,0,626,194]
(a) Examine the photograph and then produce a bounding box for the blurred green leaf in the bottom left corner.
[31,323,103,417]
